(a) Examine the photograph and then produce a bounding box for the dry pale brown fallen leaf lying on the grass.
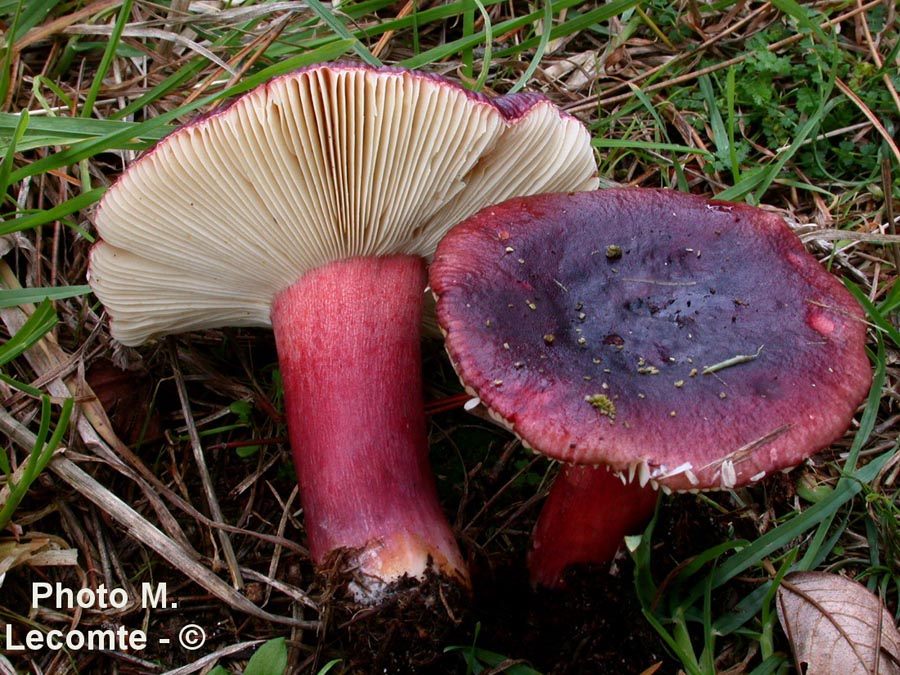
[778,572,900,675]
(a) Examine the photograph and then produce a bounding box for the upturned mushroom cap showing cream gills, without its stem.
[89,63,597,345]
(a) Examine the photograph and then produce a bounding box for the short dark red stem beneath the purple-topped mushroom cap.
[528,465,657,588]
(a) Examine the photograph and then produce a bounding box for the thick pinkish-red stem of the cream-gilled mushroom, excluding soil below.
[272,255,468,603]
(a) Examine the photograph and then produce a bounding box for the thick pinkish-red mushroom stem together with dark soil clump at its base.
[272,256,468,673]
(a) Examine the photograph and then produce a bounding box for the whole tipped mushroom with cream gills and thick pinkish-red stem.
[89,63,597,604]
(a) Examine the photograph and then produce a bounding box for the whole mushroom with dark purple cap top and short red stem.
[430,188,872,586]
